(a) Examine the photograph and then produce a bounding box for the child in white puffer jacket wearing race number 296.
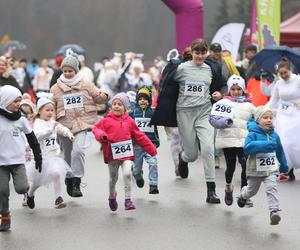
[209,75,255,206]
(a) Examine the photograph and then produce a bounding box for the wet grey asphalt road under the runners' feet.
[0,130,300,250]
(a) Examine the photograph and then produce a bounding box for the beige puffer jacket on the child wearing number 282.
[50,79,108,134]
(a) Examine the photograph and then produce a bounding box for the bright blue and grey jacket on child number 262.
[244,120,288,176]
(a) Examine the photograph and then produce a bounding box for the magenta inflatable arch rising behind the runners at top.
[162,0,204,53]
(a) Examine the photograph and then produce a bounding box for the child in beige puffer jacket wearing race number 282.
[50,49,110,197]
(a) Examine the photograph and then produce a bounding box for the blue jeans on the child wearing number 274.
[132,145,158,186]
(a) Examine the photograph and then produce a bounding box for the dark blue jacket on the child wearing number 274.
[129,105,160,148]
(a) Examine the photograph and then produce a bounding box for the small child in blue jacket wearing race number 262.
[237,106,288,225]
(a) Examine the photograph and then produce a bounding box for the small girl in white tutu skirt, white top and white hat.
[27,97,74,209]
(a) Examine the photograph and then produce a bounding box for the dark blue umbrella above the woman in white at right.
[253,46,300,73]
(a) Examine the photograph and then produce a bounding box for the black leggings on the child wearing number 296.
[223,148,247,187]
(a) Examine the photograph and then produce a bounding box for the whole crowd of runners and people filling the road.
[0,39,300,231]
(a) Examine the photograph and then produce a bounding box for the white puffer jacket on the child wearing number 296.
[215,99,255,149]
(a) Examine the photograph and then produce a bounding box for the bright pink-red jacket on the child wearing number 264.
[92,111,157,163]
